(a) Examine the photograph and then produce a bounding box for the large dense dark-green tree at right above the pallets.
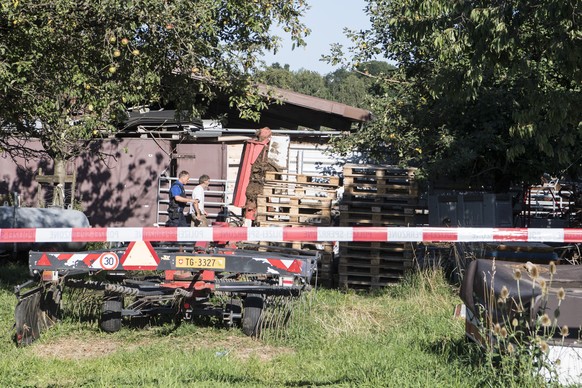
[330,0,582,189]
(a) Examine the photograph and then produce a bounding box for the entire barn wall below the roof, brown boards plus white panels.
[0,138,352,227]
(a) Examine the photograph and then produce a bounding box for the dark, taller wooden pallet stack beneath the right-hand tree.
[338,165,418,288]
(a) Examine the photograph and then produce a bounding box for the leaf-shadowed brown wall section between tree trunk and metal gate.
[76,139,171,227]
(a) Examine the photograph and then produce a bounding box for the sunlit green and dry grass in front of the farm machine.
[0,265,552,387]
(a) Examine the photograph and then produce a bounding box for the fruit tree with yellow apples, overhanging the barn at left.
[0,0,309,203]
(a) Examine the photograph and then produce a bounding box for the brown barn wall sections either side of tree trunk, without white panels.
[0,138,227,227]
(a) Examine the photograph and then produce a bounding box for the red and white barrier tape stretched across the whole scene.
[0,226,582,243]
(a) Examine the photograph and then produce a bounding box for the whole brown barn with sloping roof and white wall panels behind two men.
[0,86,371,227]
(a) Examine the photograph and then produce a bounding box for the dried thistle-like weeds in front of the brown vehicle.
[478,260,576,386]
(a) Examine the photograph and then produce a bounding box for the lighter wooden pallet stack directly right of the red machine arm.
[256,171,340,287]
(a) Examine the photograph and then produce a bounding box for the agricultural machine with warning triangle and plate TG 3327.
[15,241,319,345]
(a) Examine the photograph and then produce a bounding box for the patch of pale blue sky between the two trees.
[263,0,370,75]
